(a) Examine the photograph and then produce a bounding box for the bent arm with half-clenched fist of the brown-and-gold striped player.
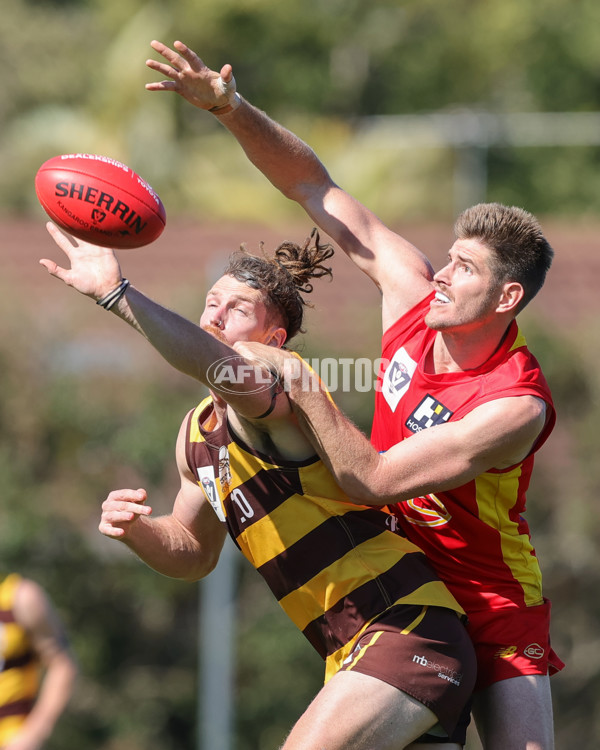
[99,420,226,581]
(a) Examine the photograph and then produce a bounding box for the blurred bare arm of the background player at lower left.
[7,579,77,750]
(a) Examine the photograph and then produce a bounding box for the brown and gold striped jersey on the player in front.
[186,397,462,679]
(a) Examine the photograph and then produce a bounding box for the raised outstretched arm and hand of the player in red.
[146,41,432,327]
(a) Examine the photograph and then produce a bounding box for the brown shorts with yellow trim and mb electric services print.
[340,605,476,744]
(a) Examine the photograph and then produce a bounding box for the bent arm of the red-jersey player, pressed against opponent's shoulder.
[239,344,546,505]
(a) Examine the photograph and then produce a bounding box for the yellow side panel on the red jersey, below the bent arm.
[475,472,543,607]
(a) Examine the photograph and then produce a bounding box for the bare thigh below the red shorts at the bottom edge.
[473,675,554,750]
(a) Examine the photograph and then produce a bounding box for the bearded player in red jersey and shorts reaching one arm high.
[146,41,563,750]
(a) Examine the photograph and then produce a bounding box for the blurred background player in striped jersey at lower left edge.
[0,573,77,750]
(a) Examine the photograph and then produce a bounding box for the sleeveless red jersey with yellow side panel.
[371,297,556,613]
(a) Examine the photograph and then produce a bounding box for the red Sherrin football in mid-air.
[35,154,166,249]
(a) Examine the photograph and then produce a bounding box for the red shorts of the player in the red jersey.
[467,599,565,690]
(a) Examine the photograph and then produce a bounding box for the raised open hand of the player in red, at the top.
[146,40,236,109]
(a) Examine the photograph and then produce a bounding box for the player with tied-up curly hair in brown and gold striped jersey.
[41,224,475,750]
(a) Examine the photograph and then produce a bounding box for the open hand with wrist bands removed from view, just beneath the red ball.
[40,221,122,299]
